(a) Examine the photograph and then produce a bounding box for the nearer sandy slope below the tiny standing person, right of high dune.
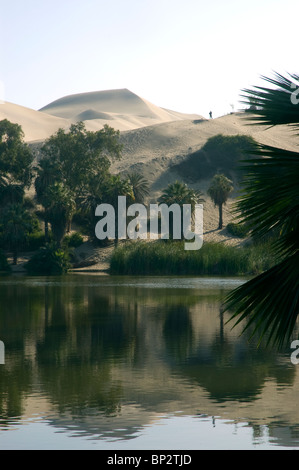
[112,113,298,198]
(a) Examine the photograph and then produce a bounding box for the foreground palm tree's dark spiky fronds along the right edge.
[225,74,299,347]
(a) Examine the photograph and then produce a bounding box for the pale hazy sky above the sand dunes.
[0,0,299,117]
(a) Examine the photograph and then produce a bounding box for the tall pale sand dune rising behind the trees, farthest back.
[0,89,201,142]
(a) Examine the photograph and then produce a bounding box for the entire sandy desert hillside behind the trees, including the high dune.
[0,89,298,250]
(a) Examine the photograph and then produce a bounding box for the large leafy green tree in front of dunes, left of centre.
[35,122,122,238]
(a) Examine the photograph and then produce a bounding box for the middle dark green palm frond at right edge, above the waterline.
[235,144,299,254]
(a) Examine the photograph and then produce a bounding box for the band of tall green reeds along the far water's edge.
[110,240,276,275]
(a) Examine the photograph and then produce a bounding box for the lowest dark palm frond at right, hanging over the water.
[225,253,299,348]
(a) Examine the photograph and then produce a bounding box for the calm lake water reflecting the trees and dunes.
[0,275,299,450]
